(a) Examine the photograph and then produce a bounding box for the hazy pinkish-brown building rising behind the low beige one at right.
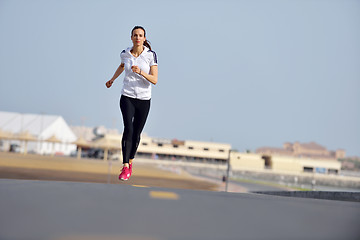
[256,142,346,159]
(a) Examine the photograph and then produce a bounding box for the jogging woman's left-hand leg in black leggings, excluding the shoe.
[120,96,135,164]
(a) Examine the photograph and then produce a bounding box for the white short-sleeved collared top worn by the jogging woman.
[120,46,158,100]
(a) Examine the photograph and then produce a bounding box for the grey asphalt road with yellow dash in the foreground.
[0,179,360,240]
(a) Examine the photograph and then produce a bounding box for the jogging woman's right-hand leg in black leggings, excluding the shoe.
[130,99,150,159]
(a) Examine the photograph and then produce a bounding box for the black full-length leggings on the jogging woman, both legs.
[120,95,150,163]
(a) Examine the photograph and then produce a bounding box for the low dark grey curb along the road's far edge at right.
[252,191,360,202]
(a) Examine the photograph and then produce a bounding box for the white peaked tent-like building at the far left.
[0,112,76,155]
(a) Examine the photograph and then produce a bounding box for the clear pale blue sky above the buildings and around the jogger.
[0,0,360,156]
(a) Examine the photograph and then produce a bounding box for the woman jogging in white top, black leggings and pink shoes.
[106,26,158,180]
